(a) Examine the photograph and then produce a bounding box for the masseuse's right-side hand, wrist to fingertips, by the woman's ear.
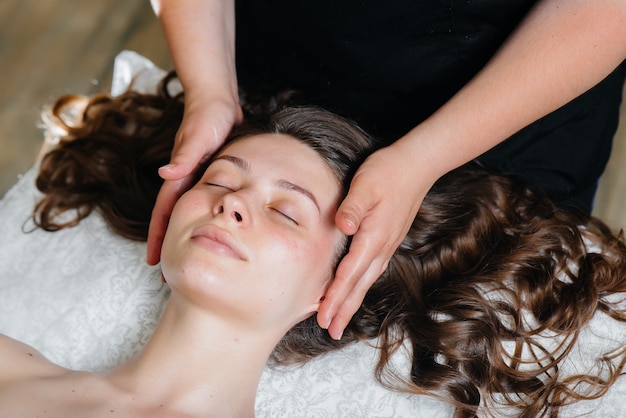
[318,143,433,339]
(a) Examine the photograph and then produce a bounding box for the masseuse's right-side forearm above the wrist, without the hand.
[397,0,626,181]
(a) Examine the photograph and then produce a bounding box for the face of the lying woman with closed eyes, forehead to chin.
[161,134,343,331]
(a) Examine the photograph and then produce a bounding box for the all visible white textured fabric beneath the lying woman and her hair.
[0,51,626,418]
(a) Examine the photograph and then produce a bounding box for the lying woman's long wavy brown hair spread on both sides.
[34,75,626,417]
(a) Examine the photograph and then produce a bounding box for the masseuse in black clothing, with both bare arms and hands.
[148,0,626,338]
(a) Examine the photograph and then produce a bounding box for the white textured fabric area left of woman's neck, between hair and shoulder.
[0,168,169,370]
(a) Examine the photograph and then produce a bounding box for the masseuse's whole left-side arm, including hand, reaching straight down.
[147,0,242,264]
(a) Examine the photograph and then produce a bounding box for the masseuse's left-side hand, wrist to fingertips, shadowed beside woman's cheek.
[147,96,243,264]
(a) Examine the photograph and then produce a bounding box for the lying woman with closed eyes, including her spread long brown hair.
[12,76,626,417]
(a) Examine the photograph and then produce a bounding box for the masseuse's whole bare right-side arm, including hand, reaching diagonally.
[318,0,626,338]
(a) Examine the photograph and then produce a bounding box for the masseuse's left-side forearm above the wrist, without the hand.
[151,0,237,98]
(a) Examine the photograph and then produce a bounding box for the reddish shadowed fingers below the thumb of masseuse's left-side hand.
[146,176,193,265]
